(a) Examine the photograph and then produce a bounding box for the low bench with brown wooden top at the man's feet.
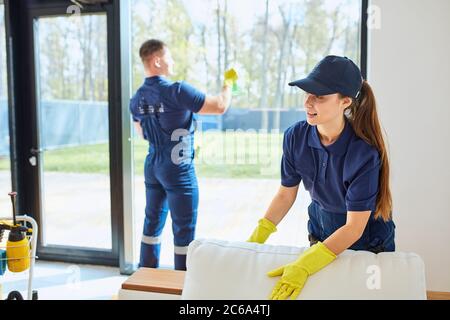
[119,268,185,300]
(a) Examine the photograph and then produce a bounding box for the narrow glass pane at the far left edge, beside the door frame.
[0,4,12,217]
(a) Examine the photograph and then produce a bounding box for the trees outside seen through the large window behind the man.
[132,0,360,108]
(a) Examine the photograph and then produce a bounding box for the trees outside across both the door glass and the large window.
[29,0,360,108]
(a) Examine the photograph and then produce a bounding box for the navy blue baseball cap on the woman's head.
[289,56,363,99]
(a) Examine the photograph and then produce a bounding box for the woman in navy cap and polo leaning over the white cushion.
[248,56,395,299]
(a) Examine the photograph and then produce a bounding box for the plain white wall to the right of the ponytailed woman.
[368,0,450,292]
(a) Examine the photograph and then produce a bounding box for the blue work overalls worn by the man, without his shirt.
[138,94,198,270]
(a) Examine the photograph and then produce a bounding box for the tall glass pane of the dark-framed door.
[35,14,112,249]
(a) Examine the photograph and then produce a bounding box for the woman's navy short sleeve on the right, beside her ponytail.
[345,149,381,211]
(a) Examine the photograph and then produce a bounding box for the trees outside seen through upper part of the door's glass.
[37,14,108,101]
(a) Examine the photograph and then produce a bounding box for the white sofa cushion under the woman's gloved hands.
[182,239,426,300]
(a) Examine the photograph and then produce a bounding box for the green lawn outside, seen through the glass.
[0,131,283,179]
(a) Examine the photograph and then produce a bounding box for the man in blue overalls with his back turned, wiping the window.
[130,39,237,270]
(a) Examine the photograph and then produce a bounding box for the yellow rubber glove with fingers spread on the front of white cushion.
[267,242,336,300]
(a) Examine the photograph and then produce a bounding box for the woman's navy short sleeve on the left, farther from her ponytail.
[281,128,302,188]
